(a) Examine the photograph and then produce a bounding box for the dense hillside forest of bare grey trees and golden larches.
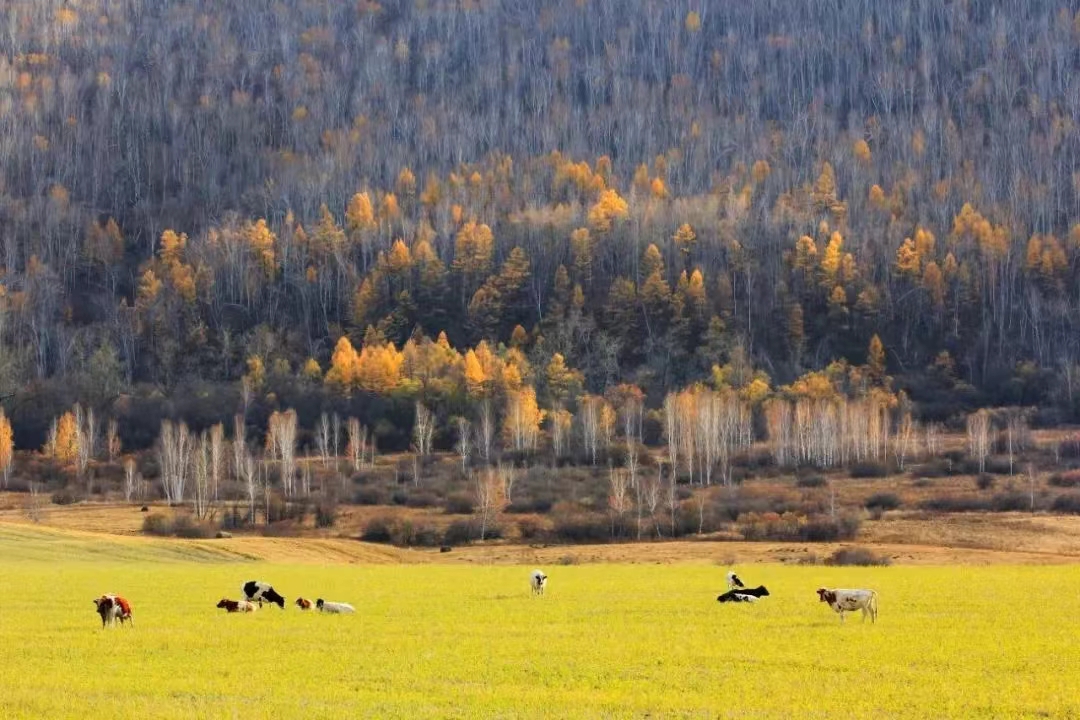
[0,0,1080,450]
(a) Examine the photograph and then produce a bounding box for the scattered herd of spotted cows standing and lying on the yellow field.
[94,570,877,629]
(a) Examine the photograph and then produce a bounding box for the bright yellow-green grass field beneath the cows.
[0,526,1080,719]
